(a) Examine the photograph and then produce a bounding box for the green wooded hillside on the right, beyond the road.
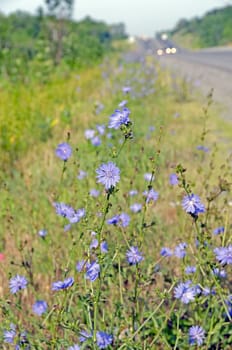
[171,5,232,47]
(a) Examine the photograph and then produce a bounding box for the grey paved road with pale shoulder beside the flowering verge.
[150,40,232,121]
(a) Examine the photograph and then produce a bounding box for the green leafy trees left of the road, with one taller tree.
[0,0,127,77]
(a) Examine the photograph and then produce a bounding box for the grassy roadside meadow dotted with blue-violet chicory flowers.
[0,45,232,350]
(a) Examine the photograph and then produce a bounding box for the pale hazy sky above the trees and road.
[0,0,228,36]
